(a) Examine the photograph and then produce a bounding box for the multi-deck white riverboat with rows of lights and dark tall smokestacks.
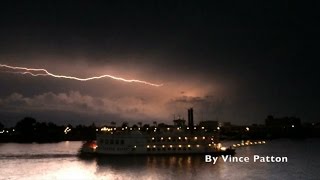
[81,108,235,155]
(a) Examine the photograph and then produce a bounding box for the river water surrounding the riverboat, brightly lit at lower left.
[0,139,320,180]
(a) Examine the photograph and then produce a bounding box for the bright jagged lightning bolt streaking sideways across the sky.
[0,64,163,87]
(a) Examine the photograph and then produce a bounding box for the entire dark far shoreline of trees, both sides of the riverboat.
[0,115,320,143]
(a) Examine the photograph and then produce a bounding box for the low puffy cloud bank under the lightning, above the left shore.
[0,91,163,124]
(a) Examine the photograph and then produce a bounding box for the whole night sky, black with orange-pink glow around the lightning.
[0,0,320,125]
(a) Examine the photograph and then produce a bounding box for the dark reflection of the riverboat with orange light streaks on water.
[92,156,212,179]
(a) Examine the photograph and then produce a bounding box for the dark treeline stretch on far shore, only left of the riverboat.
[0,117,96,143]
